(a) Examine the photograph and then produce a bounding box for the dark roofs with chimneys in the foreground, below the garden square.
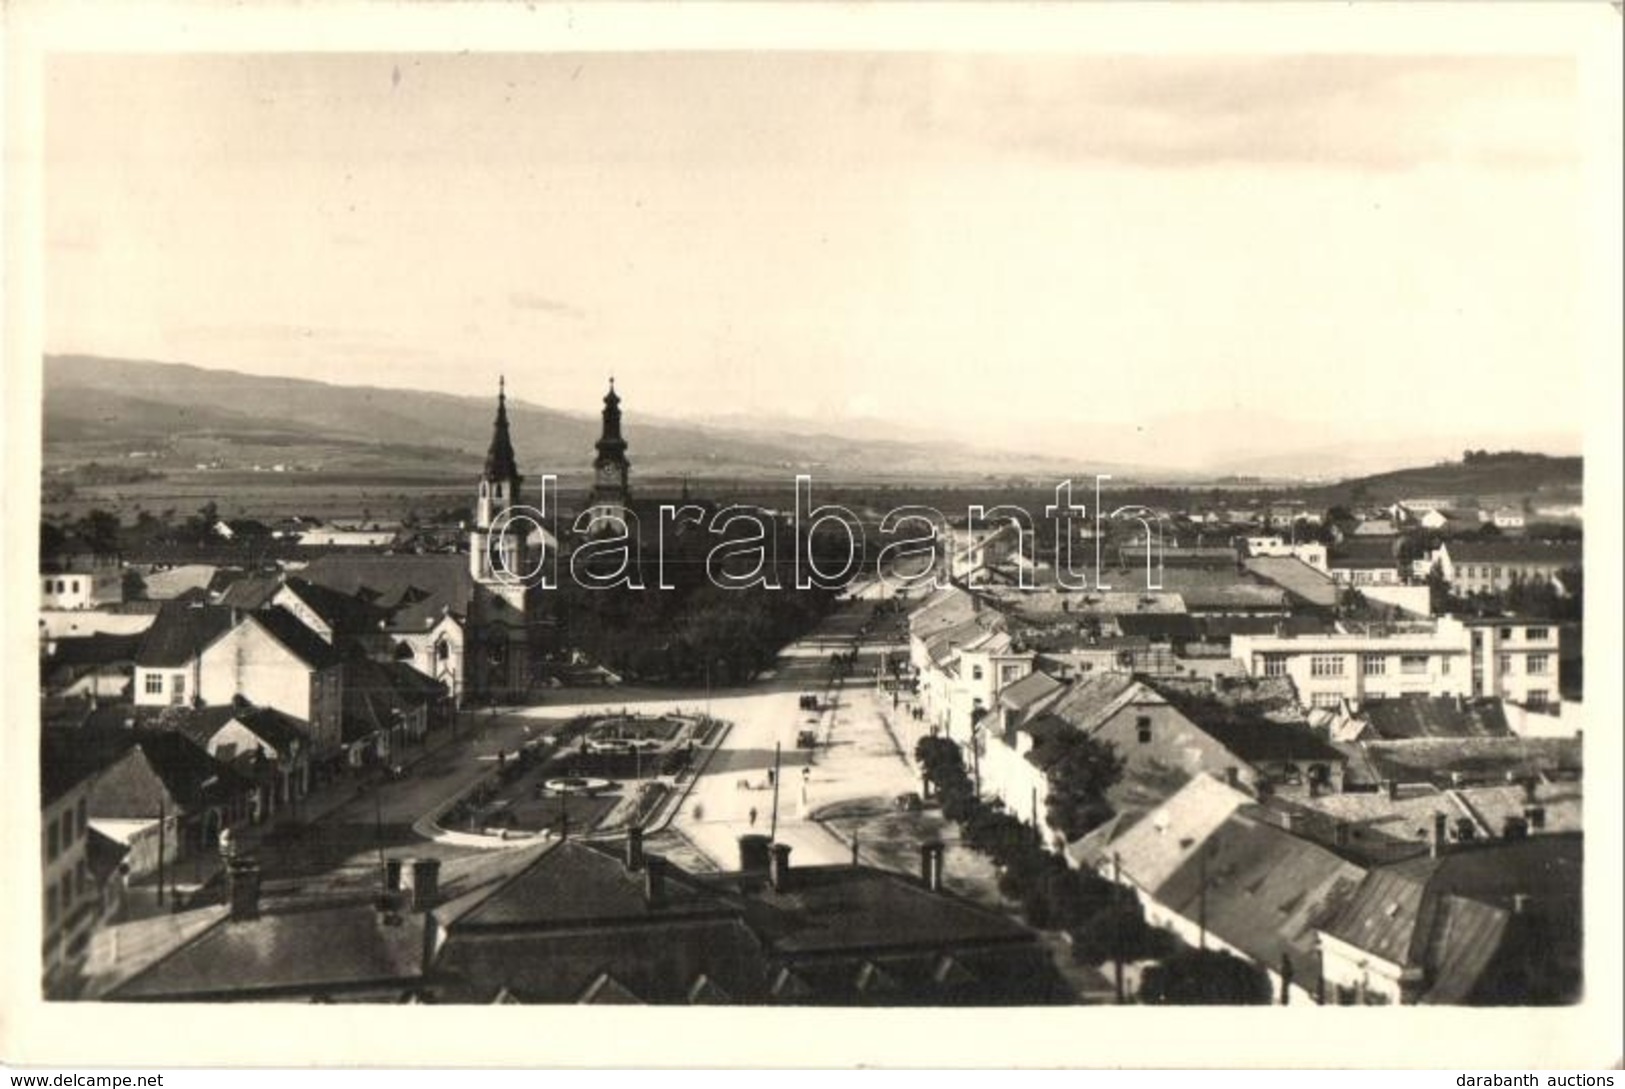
[69,831,1073,1006]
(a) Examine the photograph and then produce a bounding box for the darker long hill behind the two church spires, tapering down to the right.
[44,354,1157,479]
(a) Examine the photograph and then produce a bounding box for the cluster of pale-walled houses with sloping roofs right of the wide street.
[905,585,1581,1003]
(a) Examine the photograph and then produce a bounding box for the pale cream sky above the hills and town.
[44,52,1584,457]
